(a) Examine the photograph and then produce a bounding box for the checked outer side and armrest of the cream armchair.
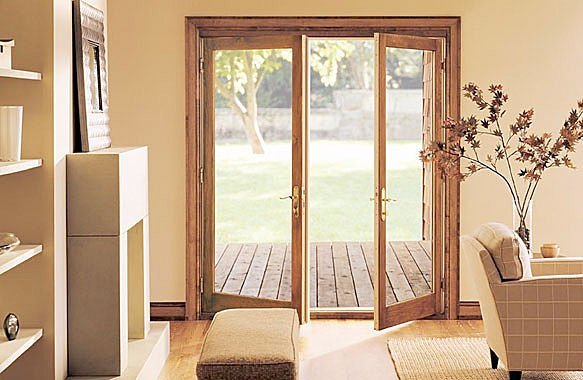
[491,275,583,371]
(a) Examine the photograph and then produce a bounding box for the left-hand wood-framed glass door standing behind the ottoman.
[200,35,307,321]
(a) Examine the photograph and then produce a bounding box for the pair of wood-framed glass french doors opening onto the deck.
[200,34,444,329]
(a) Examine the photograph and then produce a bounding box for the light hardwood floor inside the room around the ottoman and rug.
[159,320,488,380]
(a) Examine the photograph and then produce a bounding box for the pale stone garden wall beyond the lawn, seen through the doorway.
[215,89,423,141]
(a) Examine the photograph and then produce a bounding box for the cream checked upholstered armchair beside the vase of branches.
[461,223,583,380]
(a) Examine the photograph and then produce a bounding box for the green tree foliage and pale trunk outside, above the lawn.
[214,40,422,153]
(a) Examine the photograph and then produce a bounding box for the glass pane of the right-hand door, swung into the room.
[385,47,433,305]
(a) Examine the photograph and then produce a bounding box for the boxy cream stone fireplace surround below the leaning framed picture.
[67,147,169,378]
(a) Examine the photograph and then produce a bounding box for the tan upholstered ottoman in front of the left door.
[196,309,299,380]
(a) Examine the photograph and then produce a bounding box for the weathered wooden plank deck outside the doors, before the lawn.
[215,241,432,308]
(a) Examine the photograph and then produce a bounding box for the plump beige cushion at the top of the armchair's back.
[474,223,532,281]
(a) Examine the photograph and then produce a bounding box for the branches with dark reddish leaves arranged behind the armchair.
[420,82,583,249]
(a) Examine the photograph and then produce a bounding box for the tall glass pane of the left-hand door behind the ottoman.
[214,49,292,301]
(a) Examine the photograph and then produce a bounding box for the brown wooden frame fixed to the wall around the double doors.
[185,17,461,320]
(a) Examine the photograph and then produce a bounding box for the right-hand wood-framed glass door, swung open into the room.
[374,34,444,330]
